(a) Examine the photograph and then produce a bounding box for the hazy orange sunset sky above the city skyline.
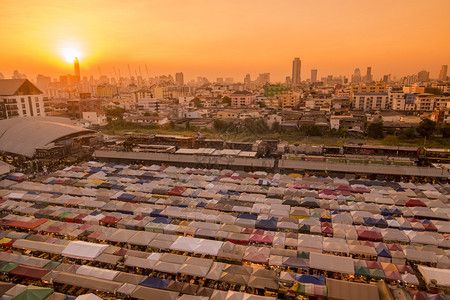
[0,0,450,81]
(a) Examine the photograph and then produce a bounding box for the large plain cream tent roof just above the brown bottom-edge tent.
[309,252,355,274]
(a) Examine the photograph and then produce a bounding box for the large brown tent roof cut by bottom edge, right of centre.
[327,278,380,300]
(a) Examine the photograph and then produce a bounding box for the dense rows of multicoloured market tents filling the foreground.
[0,163,450,299]
